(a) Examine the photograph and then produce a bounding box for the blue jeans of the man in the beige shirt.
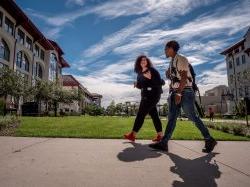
[162,88,211,143]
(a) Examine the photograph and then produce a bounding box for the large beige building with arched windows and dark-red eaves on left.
[0,0,69,113]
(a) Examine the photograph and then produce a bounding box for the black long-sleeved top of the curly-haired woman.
[136,67,165,96]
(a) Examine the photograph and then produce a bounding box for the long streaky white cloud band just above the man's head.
[110,1,250,60]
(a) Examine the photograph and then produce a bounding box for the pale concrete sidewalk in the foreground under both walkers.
[0,137,250,187]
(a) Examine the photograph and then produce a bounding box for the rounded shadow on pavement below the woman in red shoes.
[117,142,162,162]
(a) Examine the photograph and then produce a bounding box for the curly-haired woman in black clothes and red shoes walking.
[124,55,165,142]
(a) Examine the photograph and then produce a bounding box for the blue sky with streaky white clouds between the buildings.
[16,0,250,107]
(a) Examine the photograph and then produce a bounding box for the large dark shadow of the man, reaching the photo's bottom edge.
[166,153,221,187]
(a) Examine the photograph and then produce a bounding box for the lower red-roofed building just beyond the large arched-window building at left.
[60,75,102,113]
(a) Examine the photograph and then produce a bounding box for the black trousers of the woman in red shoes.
[133,90,162,132]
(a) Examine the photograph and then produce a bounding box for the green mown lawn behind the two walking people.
[15,116,250,141]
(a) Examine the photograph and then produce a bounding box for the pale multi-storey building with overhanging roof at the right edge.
[221,27,250,102]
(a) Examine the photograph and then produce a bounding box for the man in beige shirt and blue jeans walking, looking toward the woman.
[149,41,217,153]
